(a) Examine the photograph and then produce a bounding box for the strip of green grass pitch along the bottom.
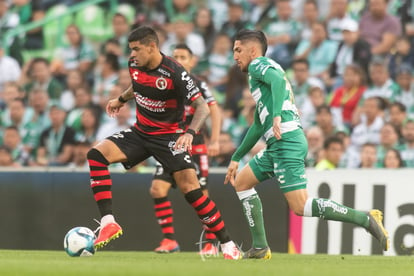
[0,250,414,276]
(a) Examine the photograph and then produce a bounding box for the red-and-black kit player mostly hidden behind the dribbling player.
[150,44,221,255]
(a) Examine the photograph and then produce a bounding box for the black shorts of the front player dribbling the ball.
[106,126,195,173]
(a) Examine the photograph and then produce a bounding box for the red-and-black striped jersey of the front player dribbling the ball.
[128,55,202,135]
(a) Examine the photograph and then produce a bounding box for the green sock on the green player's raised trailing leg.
[304,198,369,228]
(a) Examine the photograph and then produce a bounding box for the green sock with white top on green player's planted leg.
[237,189,268,248]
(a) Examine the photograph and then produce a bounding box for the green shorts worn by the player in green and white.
[249,132,308,193]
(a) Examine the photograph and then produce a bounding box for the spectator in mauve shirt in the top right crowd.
[359,0,401,56]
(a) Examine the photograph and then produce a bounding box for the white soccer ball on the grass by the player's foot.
[63,226,95,257]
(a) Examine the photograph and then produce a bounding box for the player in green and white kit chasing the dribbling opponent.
[224,30,389,259]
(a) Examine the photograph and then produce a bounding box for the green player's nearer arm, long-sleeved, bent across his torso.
[263,68,287,140]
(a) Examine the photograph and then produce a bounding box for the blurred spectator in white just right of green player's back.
[298,86,325,130]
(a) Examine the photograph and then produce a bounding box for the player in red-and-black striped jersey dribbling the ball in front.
[87,26,241,259]
